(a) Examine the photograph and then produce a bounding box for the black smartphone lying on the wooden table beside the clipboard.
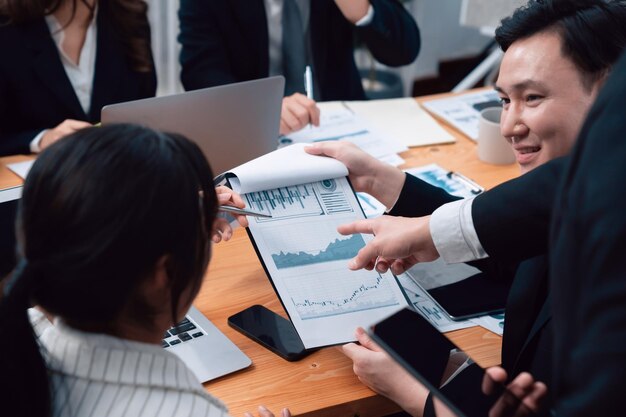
[228,304,314,361]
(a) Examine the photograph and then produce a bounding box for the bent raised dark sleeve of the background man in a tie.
[357,0,420,67]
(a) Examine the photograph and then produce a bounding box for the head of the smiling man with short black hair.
[496,0,626,173]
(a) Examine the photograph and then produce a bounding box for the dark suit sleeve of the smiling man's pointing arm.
[472,158,566,263]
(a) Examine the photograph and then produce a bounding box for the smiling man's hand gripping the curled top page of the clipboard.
[304,141,406,209]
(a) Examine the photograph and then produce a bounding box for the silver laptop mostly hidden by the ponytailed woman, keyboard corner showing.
[0,186,252,382]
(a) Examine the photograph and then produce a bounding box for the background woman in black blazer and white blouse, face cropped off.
[0,0,156,155]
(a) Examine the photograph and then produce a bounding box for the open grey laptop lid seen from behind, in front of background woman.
[101,76,285,175]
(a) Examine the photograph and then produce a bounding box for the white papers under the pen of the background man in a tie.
[281,102,407,166]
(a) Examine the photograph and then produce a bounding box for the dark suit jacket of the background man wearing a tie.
[179,0,420,101]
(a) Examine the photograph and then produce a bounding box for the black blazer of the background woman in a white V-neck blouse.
[0,7,156,155]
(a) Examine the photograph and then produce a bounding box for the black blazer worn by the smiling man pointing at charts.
[390,172,561,395]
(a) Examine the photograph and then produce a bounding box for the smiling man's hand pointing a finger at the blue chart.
[337,216,439,274]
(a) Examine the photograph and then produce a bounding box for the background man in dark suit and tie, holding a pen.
[179,0,420,134]
